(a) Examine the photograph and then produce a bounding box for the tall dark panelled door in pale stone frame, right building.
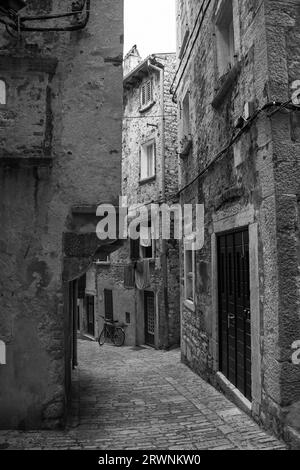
[218,230,251,400]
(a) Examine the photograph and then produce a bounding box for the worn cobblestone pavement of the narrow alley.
[0,341,285,450]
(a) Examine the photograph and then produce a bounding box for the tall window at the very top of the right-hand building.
[216,0,235,77]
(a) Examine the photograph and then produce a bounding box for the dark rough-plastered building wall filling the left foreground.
[0,0,123,429]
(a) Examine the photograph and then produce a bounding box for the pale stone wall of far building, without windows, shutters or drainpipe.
[98,54,180,347]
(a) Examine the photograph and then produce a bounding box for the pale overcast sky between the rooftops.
[124,0,176,58]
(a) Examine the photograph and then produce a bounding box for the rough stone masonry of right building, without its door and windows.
[175,0,300,440]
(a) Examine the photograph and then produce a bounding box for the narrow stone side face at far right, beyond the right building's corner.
[264,0,300,438]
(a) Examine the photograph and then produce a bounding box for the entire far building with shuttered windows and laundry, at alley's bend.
[97,46,180,348]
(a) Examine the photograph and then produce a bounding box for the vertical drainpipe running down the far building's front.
[148,59,169,349]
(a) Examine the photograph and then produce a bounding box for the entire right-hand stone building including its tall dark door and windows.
[172,0,300,440]
